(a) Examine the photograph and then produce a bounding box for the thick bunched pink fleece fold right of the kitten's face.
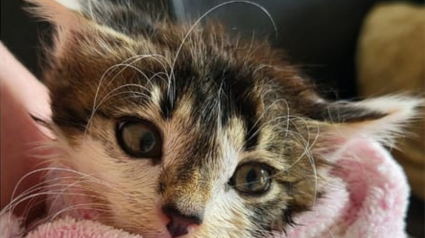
[283,140,409,238]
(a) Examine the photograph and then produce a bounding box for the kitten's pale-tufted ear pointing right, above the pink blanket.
[310,96,425,152]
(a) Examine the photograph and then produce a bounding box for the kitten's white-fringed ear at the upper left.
[26,0,136,76]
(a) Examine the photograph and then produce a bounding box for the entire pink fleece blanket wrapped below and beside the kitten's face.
[0,139,409,238]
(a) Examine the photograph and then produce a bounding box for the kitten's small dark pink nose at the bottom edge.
[162,205,202,237]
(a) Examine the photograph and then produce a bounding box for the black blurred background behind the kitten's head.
[0,0,424,238]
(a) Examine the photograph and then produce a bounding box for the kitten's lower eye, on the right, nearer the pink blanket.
[229,163,271,195]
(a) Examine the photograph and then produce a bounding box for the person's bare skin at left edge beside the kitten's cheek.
[0,43,50,219]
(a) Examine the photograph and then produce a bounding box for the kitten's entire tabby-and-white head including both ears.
[31,0,418,237]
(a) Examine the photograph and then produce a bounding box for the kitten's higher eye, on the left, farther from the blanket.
[116,118,162,158]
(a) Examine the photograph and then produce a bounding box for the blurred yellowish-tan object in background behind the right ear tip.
[357,3,425,200]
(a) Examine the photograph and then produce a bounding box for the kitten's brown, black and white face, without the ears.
[50,23,317,237]
